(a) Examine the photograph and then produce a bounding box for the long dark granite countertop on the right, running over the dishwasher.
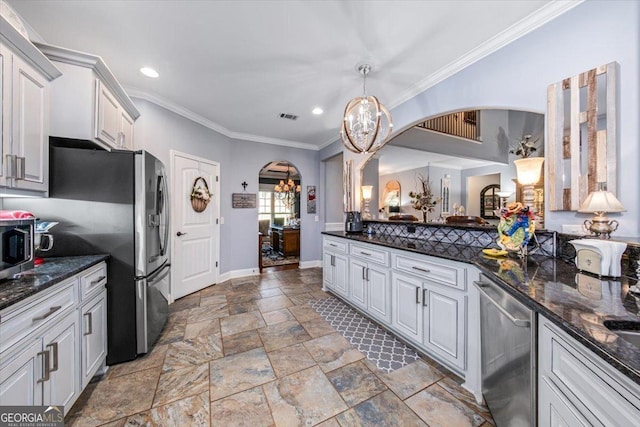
[323,231,640,384]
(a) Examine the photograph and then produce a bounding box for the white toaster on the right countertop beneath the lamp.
[569,239,627,277]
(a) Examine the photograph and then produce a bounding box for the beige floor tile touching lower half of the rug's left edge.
[304,332,364,372]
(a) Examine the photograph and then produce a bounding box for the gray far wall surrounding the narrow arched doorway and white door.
[134,98,323,273]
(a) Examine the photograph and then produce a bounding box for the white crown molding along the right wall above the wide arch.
[389,0,585,109]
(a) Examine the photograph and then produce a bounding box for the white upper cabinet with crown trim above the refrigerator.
[36,43,140,150]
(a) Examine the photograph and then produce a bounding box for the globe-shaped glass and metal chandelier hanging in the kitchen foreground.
[340,64,393,153]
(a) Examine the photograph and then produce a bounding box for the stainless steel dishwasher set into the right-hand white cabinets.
[474,274,537,427]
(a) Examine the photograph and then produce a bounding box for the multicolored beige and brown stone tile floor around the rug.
[65,268,493,427]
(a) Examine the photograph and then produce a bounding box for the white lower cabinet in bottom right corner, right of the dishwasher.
[538,316,640,427]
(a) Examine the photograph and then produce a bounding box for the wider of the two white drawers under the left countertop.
[0,278,77,353]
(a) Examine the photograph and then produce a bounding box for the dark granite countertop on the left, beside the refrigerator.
[0,255,109,310]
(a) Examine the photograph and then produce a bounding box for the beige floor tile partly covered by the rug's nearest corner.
[366,360,442,400]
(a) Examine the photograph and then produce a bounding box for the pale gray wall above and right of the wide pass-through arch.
[320,0,640,236]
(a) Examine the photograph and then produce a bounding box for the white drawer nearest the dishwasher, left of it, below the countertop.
[393,255,466,290]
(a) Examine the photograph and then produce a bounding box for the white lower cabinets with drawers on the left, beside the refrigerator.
[0,262,107,410]
